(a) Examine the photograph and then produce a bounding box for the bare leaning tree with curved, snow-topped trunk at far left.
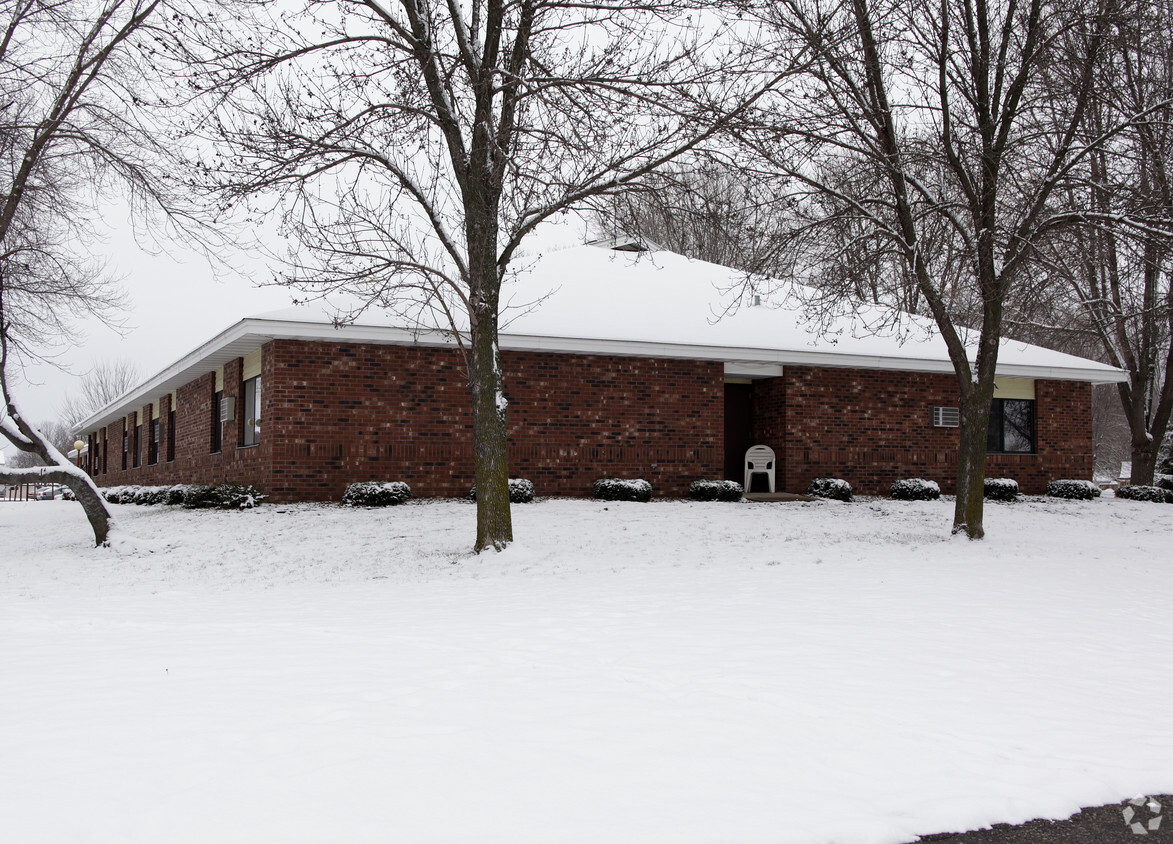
[0,0,187,545]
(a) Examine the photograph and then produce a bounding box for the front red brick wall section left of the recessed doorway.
[262,341,723,501]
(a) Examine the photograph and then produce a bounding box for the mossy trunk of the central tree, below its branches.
[468,318,513,553]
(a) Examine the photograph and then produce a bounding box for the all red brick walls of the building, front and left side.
[85,340,1092,502]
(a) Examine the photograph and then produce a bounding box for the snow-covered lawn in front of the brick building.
[0,498,1173,844]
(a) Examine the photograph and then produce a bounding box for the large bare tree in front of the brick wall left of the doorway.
[167,0,784,551]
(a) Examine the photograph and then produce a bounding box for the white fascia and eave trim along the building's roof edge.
[77,318,1128,433]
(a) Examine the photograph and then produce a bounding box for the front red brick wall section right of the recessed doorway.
[778,367,1092,495]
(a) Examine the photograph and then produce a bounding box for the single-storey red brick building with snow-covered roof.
[80,240,1124,502]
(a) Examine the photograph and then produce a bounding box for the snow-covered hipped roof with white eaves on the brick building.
[81,246,1125,429]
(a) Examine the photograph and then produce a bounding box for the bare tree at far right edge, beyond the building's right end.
[1026,0,1173,484]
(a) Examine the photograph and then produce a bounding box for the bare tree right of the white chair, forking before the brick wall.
[740,0,1114,539]
